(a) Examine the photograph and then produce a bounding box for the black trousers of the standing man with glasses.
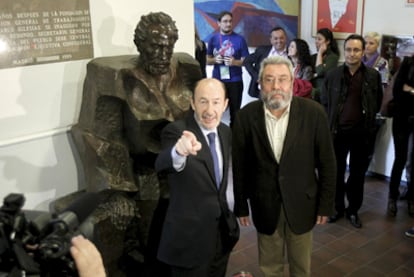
[334,127,374,214]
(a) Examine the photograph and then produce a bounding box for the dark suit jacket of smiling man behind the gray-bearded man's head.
[243,45,272,98]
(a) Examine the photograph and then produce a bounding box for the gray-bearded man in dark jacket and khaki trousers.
[232,57,336,277]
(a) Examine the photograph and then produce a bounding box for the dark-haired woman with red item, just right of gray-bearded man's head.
[288,38,313,98]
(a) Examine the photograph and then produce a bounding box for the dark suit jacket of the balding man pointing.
[155,113,231,268]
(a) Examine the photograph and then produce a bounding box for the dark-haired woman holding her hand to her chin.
[312,28,339,102]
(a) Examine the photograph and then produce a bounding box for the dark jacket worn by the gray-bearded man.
[232,97,336,235]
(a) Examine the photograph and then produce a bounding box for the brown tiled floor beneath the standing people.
[227,177,414,277]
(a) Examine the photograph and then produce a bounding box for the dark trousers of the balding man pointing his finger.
[171,226,230,277]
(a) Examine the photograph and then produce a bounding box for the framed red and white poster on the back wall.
[312,0,364,39]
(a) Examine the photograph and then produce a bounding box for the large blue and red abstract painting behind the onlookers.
[194,0,301,47]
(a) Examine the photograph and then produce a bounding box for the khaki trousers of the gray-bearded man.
[257,209,312,277]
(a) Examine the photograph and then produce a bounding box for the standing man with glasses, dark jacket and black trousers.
[321,34,382,228]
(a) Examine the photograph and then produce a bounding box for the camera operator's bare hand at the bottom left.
[70,236,106,277]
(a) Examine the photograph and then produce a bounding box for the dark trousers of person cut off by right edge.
[389,116,414,201]
